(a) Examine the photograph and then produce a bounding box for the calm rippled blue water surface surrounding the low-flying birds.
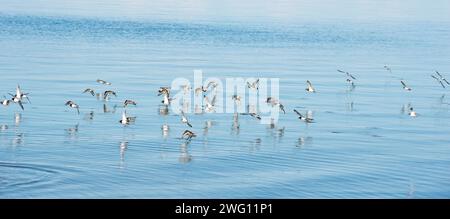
[0,0,450,198]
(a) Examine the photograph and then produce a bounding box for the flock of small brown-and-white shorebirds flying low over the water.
[1,66,450,145]
